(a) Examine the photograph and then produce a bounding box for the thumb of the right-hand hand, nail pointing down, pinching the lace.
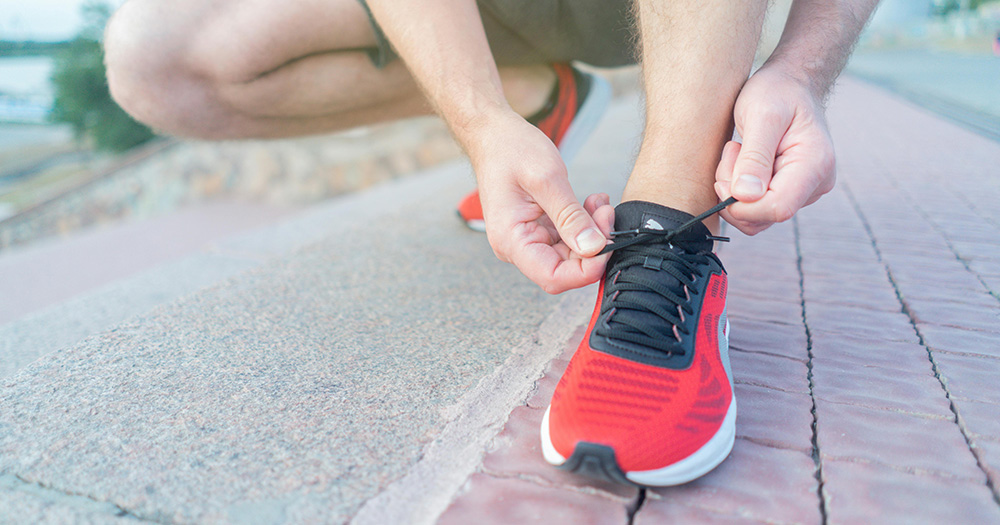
[729,111,789,202]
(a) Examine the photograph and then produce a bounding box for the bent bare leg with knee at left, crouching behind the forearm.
[106,0,554,138]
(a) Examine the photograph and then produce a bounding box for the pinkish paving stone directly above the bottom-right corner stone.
[816,399,984,482]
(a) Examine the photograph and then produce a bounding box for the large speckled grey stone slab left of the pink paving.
[0,97,639,522]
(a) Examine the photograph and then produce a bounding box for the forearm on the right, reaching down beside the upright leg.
[768,0,878,100]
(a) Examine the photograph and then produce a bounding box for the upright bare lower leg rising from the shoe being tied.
[622,0,767,231]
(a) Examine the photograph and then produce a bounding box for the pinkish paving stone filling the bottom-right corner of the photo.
[823,461,1000,525]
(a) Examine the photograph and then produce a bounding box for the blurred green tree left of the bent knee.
[52,1,155,151]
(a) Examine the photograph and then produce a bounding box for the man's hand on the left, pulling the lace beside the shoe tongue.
[463,111,614,294]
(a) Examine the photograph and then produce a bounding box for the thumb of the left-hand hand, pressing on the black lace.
[525,176,607,257]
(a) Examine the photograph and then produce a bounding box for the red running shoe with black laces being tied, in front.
[541,201,736,486]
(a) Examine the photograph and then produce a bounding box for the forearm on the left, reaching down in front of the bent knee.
[368,0,511,147]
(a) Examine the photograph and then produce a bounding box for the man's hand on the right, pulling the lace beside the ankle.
[715,64,836,235]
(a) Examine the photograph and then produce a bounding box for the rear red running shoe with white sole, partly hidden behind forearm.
[456,64,611,232]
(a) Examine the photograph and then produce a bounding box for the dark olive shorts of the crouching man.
[358,0,637,68]
